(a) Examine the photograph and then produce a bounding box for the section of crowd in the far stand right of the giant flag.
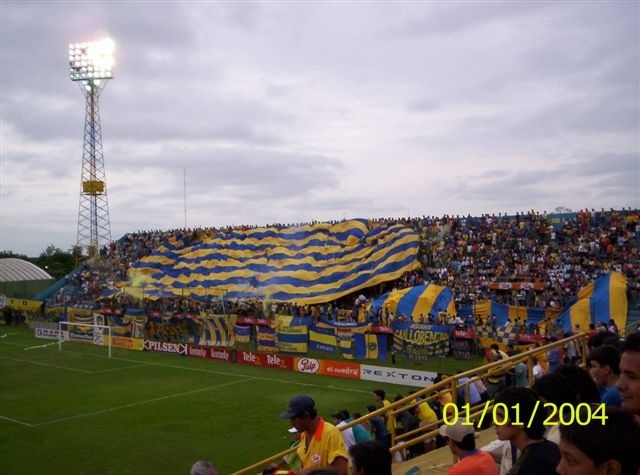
[407,209,640,308]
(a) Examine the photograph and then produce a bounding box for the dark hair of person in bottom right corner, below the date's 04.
[560,405,640,475]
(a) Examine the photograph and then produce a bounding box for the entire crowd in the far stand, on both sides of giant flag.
[47,209,640,316]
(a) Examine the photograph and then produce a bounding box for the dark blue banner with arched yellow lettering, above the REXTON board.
[393,321,452,361]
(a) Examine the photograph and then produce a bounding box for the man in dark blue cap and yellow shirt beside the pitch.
[280,395,349,475]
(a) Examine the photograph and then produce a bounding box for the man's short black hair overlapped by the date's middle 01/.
[494,388,547,440]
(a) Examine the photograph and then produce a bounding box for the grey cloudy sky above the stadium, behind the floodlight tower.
[0,0,640,256]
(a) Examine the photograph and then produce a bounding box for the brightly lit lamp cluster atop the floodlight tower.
[69,39,115,83]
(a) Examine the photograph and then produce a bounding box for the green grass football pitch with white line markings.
[0,327,436,475]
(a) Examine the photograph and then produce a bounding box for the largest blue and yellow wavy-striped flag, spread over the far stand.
[123,219,420,304]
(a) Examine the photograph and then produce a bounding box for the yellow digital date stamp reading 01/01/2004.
[442,401,607,427]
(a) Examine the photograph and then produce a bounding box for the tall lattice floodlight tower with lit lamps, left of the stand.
[69,39,114,258]
